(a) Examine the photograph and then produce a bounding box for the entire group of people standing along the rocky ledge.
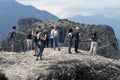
[10,26,97,60]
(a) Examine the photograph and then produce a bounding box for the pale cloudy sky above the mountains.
[16,0,120,18]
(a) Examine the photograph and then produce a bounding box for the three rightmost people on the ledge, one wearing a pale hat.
[68,27,97,54]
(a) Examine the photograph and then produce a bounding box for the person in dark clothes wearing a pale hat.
[73,27,80,53]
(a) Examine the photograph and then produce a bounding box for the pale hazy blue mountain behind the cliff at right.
[69,15,120,39]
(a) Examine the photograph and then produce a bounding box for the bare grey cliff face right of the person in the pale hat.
[79,25,118,57]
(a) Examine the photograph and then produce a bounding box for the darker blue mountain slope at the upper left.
[0,0,59,40]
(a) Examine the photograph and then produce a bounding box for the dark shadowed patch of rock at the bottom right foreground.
[36,60,120,80]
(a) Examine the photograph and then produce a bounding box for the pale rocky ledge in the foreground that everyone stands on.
[0,48,120,80]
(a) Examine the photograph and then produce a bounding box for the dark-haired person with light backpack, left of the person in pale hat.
[68,28,73,54]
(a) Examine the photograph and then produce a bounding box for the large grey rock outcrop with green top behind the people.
[30,20,118,57]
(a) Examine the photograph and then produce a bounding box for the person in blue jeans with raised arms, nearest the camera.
[36,31,46,60]
